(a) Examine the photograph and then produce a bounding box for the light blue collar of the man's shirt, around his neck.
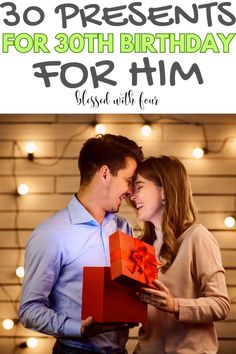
[67,195,115,225]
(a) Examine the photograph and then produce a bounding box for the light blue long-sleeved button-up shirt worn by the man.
[19,196,131,354]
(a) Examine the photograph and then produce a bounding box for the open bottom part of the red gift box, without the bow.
[82,267,147,322]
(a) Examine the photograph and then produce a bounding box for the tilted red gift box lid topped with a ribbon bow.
[109,231,159,289]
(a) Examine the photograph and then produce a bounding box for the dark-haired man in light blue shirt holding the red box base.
[19,134,143,354]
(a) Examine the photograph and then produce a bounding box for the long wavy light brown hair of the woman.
[137,156,197,272]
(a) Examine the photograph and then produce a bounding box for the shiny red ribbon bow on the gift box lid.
[128,246,158,284]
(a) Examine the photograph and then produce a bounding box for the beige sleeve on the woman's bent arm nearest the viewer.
[178,227,230,323]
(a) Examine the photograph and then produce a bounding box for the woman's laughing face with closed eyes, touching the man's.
[131,174,164,224]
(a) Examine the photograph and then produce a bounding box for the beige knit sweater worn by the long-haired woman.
[135,224,230,354]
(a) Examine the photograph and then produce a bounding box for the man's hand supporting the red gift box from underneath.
[81,316,139,337]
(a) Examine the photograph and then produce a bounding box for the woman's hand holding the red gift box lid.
[137,279,179,314]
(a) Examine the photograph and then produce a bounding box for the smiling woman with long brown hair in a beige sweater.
[131,156,230,354]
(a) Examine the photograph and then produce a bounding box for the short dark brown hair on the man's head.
[78,134,143,185]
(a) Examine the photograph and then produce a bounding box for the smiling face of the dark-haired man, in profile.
[104,158,137,213]
